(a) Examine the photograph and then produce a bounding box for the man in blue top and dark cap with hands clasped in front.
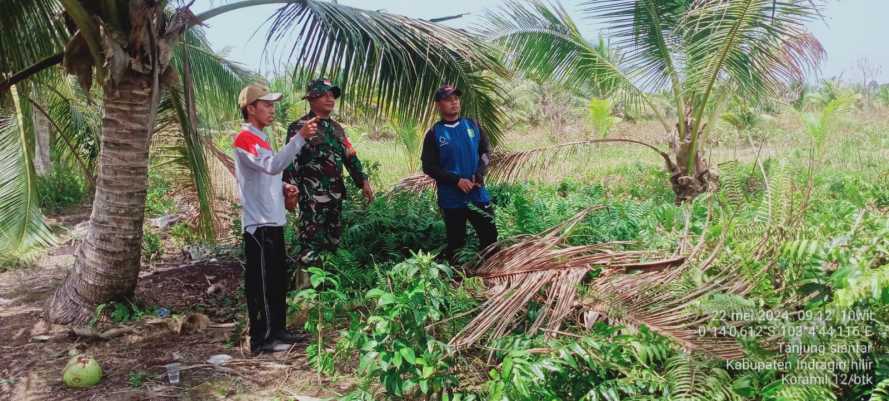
[421,85,497,262]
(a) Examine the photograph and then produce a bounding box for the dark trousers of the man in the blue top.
[441,204,497,262]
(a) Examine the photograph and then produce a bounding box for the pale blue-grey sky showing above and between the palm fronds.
[192,0,889,83]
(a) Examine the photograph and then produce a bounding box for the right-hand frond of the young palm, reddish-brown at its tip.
[681,0,824,121]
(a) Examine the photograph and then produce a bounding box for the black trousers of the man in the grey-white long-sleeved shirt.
[244,227,288,349]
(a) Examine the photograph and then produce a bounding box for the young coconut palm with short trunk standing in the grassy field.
[486,0,824,202]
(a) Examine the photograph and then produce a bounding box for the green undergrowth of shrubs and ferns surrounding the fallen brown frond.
[274,151,889,401]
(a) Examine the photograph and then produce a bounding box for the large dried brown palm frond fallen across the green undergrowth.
[450,207,751,359]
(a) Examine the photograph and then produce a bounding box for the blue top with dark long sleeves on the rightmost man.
[421,117,491,209]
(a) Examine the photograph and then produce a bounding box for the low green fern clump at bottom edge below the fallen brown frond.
[487,325,742,401]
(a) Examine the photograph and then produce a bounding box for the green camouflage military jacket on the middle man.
[283,112,367,203]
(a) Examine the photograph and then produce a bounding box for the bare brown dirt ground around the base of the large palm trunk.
[0,211,350,401]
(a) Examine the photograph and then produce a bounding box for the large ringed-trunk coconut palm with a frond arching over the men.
[0,0,504,323]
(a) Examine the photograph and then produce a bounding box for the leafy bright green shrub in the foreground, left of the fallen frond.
[343,253,475,399]
